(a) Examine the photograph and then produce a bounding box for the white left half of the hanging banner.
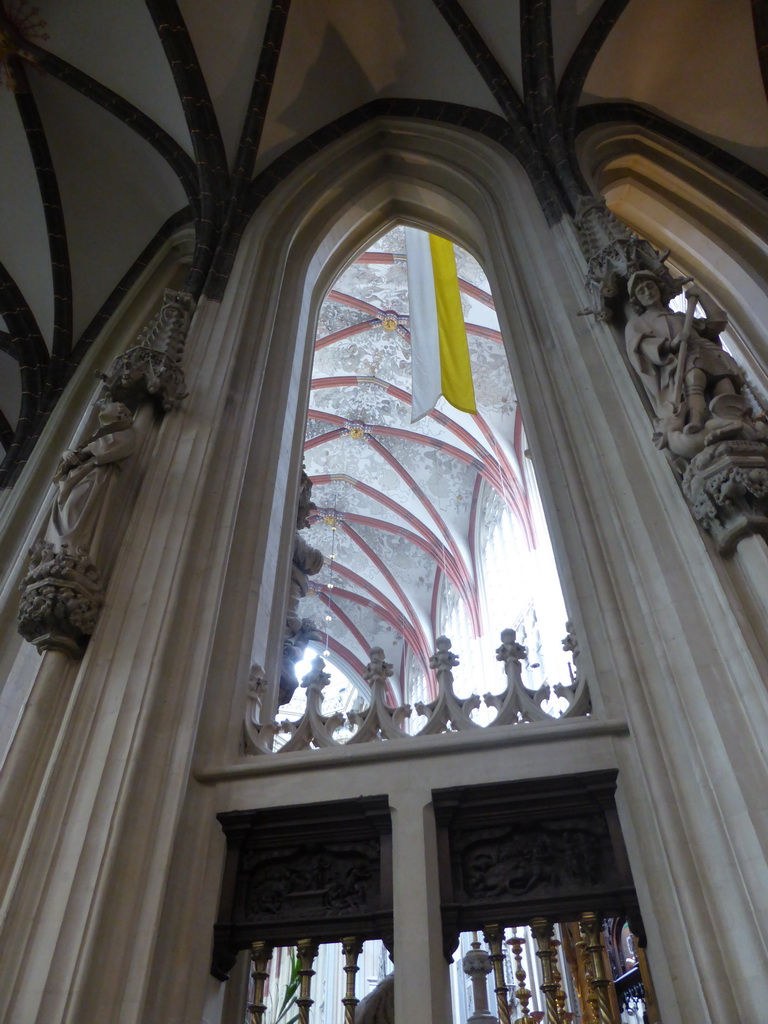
[406,227,441,423]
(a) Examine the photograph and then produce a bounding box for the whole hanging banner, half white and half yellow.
[406,227,477,423]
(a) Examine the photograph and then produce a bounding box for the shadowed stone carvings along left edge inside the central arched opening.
[279,469,324,705]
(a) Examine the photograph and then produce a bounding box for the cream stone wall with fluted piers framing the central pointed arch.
[0,120,768,1024]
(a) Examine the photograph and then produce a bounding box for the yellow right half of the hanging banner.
[429,234,477,413]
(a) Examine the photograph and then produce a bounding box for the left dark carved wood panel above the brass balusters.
[211,797,392,980]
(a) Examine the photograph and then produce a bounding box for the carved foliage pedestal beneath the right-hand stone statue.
[683,440,768,555]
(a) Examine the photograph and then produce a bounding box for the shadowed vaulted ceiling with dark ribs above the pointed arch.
[0,0,768,485]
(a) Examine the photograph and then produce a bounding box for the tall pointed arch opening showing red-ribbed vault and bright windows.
[264,226,574,737]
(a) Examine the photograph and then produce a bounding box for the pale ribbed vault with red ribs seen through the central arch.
[301,228,534,696]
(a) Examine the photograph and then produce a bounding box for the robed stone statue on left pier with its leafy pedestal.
[18,401,135,657]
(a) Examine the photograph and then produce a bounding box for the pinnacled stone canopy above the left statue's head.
[97,289,195,412]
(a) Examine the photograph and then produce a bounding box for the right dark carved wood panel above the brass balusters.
[434,771,637,956]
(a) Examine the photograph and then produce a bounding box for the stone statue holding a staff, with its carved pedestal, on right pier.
[626,272,768,555]
